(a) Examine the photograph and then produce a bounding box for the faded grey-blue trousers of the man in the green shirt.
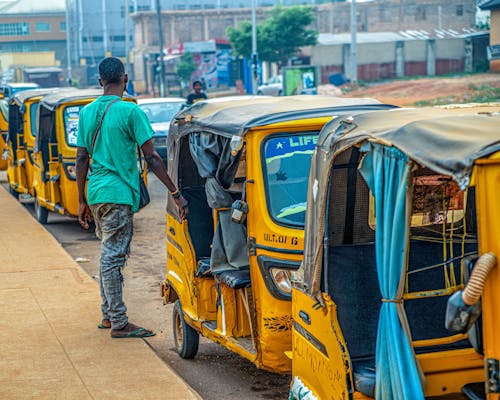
[90,203,133,329]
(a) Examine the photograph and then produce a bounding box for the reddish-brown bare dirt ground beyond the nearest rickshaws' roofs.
[319,73,500,106]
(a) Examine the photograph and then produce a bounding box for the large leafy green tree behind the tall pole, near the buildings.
[227,6,318,66]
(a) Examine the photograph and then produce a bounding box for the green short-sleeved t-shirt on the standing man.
[77,96,154,212]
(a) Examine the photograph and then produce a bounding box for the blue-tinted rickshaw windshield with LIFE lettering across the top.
[263,132,318,227]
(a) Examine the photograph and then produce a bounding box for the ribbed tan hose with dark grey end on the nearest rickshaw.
[445,253,497,333]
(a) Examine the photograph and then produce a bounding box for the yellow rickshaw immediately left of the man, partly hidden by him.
[33,89,135,224]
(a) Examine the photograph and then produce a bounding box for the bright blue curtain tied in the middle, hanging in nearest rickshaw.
[360,142,424,400]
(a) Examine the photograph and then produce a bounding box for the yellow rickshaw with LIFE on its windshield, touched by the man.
[161,96,392,372]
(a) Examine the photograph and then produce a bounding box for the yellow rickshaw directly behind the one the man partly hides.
[7,89,63,198]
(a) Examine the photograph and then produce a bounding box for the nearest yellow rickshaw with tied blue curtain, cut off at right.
[290,103,500,400]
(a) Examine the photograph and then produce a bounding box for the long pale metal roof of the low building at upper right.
[318,27,486,45]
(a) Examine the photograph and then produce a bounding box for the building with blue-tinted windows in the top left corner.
[0,0,66,79]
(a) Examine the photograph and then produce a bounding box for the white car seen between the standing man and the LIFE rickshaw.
[137,97,186,161]
